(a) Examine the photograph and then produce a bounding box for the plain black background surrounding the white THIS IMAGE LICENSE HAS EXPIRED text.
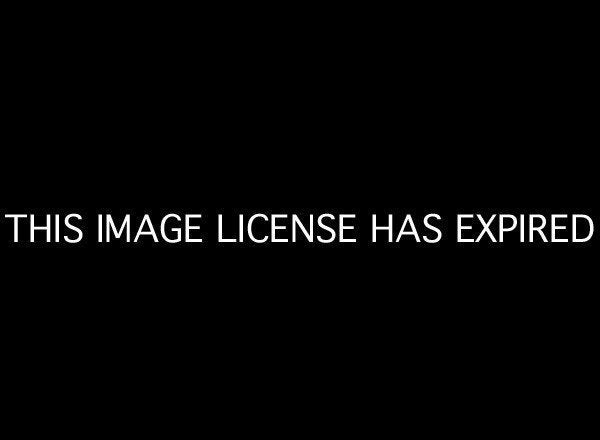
[1,5,598,433]
